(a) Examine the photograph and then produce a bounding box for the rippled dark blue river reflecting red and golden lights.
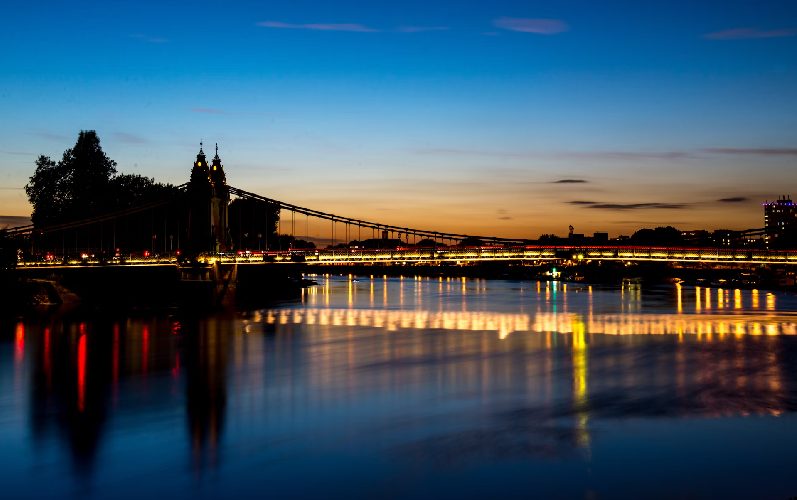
[0,277,797,498]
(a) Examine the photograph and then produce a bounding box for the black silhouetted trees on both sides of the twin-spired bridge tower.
[21,130,279,258]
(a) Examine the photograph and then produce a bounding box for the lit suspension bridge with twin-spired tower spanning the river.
[6,148,797,268]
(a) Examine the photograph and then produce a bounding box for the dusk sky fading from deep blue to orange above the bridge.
[0,0,797,238]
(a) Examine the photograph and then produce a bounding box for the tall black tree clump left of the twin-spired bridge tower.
[25,130,187,256]
